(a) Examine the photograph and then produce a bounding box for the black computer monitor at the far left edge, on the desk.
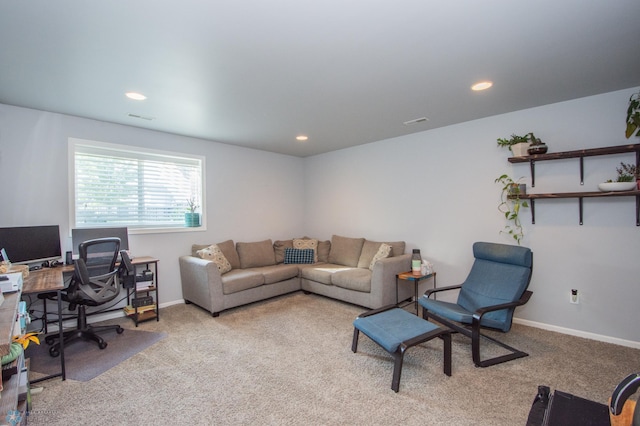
[0,225,62,264]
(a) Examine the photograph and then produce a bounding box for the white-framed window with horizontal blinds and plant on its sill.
[69,138,204,232]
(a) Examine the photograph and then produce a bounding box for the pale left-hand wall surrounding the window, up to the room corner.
[0,104,304,304]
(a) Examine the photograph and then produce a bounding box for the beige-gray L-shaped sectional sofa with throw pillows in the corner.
[179,235,412,317]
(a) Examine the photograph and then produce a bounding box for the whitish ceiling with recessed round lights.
[0,0,640,157]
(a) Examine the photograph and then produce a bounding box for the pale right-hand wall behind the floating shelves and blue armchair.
[305,88,640,347]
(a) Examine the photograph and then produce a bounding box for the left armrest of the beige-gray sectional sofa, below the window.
[178,256,223,314]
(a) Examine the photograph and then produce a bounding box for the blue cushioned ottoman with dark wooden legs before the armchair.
[351,305,451,392]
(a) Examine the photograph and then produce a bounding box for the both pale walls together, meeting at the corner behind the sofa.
[0,88,640,346]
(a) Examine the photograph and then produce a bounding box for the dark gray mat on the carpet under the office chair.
[26,330,166,382]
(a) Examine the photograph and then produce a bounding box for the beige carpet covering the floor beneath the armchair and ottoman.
[29,293,640,426]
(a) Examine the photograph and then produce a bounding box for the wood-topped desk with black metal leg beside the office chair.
[22,267,66,383]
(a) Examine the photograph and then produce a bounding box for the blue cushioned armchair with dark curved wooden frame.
[419,242,533,367]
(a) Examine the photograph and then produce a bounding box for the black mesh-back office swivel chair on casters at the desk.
[45,237,133,357]
